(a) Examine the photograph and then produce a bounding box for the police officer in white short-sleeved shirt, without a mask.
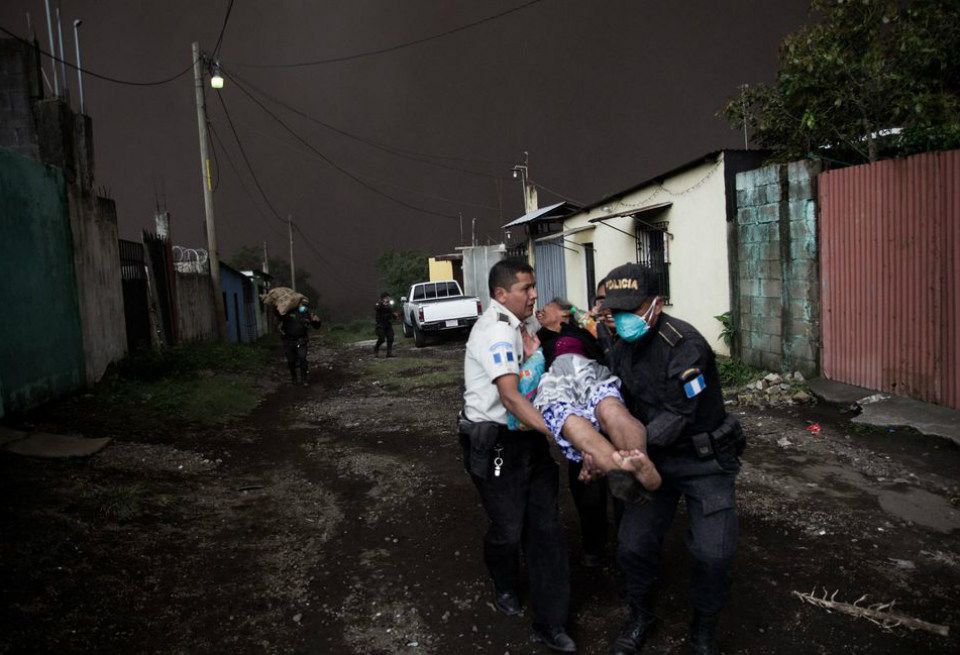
[459,259,576,653]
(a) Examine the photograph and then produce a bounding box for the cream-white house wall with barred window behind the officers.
[564,154,730,355]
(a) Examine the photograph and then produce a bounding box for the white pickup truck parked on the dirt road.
[400,280,483,348]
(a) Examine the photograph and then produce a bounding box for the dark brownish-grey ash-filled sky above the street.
[0,0,808,314]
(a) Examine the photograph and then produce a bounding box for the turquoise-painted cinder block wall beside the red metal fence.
[734,161,820,377]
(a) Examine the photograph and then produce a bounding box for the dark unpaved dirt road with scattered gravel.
[0,336,960,655]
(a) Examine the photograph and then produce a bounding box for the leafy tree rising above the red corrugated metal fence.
[721,0,960,163]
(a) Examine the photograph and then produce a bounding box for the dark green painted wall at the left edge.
[0,148,84,414]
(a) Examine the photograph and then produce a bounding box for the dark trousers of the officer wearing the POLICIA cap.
[618,455,738,615]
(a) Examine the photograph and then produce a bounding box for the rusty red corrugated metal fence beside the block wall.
[819,150,960,409]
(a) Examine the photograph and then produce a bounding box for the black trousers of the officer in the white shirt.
[471,428,570,627]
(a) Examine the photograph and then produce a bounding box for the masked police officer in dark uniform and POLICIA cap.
[604,264,744,655]
